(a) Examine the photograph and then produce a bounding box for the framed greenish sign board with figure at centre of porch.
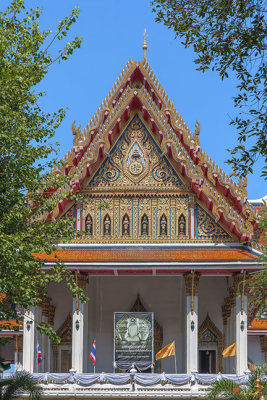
[114,312,154,364]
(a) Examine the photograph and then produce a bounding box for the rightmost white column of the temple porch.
[236,296,248,375]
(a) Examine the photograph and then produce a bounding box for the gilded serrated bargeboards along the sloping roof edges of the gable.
[54,59,257,239]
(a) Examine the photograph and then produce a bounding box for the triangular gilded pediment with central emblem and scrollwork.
[88,115,188,193]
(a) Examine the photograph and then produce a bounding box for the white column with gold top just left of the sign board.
[72,298,84,373]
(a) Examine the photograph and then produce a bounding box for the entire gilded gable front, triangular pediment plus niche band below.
[65,114,239,243]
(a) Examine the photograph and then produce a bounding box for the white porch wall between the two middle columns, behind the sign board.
[88,276,185,372]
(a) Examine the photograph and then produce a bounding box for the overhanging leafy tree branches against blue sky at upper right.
[151,0,267,178]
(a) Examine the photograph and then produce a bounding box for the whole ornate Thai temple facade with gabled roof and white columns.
[2,43,267,397]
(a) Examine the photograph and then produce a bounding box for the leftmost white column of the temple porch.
[23,307,35,373]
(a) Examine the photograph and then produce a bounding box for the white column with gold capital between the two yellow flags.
[185,273,199,374]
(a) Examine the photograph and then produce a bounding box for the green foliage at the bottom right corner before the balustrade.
[207,365,267,400]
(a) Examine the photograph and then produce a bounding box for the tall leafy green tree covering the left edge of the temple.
[0,0,86,340]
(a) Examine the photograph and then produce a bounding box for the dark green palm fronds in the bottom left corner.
[0,371,42,400]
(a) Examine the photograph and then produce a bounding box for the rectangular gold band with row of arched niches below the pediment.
[80,194,190,243]
